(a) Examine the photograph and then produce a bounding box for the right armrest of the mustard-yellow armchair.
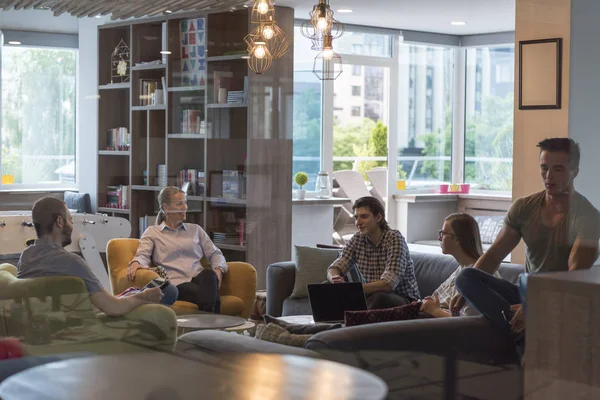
[219,262,257,318]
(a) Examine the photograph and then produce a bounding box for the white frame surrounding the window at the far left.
[0,29,79,193]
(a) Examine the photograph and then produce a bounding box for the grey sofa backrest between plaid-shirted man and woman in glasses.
[410,252,458,297]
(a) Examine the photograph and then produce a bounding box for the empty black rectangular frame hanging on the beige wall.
[519,38,562,110]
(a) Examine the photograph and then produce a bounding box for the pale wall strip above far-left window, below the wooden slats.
[0,10,79,34]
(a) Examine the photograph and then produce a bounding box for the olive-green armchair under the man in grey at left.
[0,264,177,355]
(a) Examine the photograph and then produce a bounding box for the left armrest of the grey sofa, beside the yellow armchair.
[267,261,296,317]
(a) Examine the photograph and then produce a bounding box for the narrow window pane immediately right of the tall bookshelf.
[292,27,322,189]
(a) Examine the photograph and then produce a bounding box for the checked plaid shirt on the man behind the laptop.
[329,229,421,300]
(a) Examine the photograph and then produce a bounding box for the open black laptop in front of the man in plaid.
[306,282,367,322]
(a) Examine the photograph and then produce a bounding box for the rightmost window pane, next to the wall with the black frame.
[464,45,515,192]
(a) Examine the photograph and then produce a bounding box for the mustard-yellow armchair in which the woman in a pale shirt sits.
[106,239,257,318]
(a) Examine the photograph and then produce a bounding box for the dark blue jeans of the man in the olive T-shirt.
[455,268,521,334]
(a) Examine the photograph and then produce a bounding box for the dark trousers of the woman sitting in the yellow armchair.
[177,269,221,314]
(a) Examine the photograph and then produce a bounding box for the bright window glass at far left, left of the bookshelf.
[0,46,77,189]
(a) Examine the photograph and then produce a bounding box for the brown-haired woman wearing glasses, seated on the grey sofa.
[421,213,500,318]
